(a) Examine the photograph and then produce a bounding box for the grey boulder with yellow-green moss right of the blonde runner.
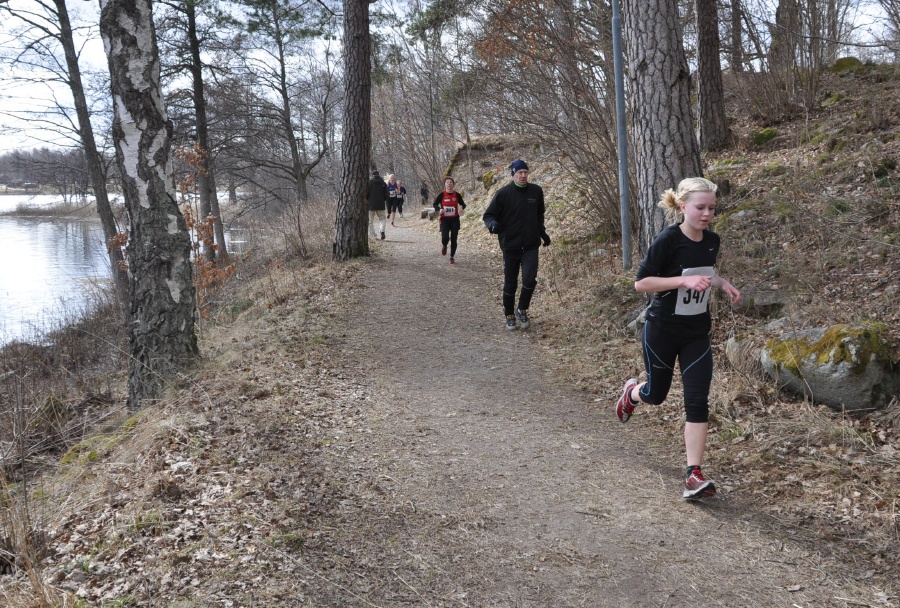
[760,323,900,412]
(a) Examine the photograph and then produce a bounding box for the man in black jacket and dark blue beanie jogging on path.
[481,160,550,330]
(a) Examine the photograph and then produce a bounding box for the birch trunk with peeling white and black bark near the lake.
[100,0,197,409]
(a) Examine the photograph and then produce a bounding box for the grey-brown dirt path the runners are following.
[326,219,868,608]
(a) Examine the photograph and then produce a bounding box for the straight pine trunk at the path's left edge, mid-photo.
[333,0,372,260]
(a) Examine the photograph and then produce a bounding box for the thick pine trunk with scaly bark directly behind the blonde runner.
[625,0,702,254]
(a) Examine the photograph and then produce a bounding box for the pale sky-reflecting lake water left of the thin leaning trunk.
[0,216,110,344]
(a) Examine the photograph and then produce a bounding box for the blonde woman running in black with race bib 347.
[616,177,741,499]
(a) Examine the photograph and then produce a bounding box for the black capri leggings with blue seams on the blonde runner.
[640,319,713,423]
